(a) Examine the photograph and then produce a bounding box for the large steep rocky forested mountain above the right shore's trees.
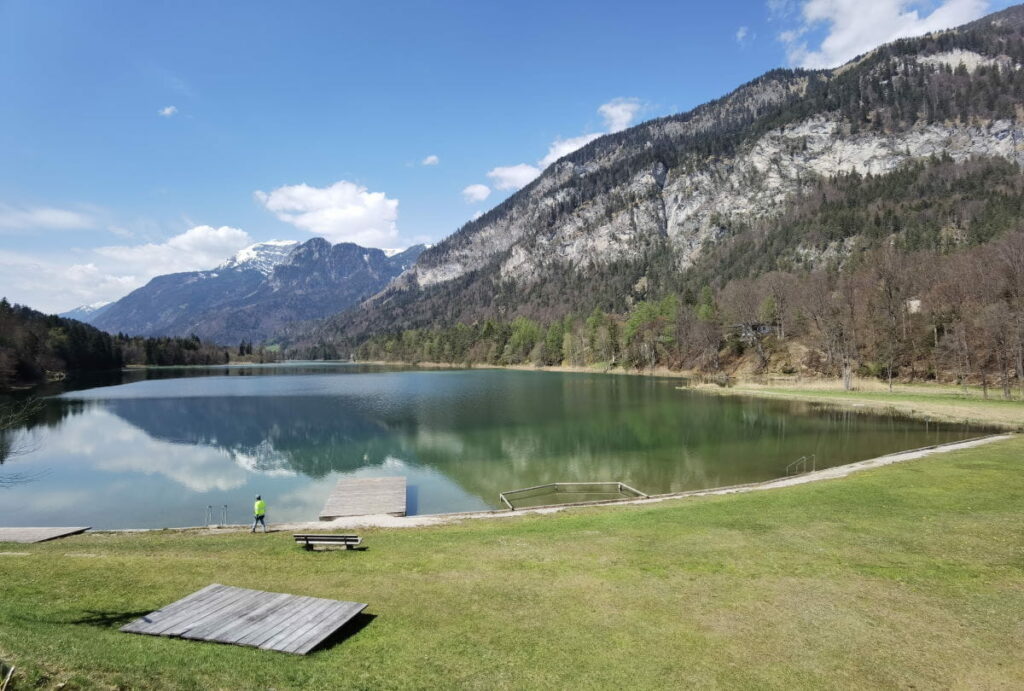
[289,5,1024,352]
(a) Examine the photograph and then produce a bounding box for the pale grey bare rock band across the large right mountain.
[402,81,1024,289]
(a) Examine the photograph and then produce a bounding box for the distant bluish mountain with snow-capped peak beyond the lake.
[89,237,423,345]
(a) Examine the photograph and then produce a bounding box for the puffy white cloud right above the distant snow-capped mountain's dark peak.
[254,180,398,247]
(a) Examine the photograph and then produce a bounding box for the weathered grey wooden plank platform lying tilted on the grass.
[121,584,366,655]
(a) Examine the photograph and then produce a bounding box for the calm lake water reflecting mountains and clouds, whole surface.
[0,363,977,528]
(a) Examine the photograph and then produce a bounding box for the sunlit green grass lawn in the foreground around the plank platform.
[0,438,1024,689]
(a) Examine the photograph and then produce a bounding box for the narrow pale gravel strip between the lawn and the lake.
[86,434,1016,535]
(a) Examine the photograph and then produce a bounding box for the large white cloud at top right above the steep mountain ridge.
[769,0,989,69]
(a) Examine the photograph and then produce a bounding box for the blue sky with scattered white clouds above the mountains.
[0,0,1010,311]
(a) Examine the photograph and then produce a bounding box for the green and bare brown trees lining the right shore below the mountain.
[354,230,1024,399]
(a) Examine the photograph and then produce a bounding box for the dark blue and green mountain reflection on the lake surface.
[94,372,964,502]
